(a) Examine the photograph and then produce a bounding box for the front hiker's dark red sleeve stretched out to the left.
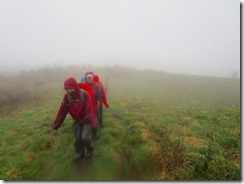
[52,94,69,130]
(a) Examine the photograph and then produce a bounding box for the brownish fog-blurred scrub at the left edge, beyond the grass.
[0,67,68,111]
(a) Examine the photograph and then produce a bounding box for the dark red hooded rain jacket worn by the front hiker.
[52,78,97,130]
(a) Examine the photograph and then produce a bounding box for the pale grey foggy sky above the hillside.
[0,0,240,77]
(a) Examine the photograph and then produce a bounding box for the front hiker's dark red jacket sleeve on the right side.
[84,92,97,128]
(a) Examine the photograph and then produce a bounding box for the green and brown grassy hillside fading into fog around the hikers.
[0,66,241,181]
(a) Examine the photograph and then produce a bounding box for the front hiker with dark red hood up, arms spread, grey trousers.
[52,78,97,160]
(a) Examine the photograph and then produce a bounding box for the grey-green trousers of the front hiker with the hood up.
[74,123,93,154]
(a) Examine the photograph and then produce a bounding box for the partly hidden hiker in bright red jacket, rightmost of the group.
[93,75,109,127]
